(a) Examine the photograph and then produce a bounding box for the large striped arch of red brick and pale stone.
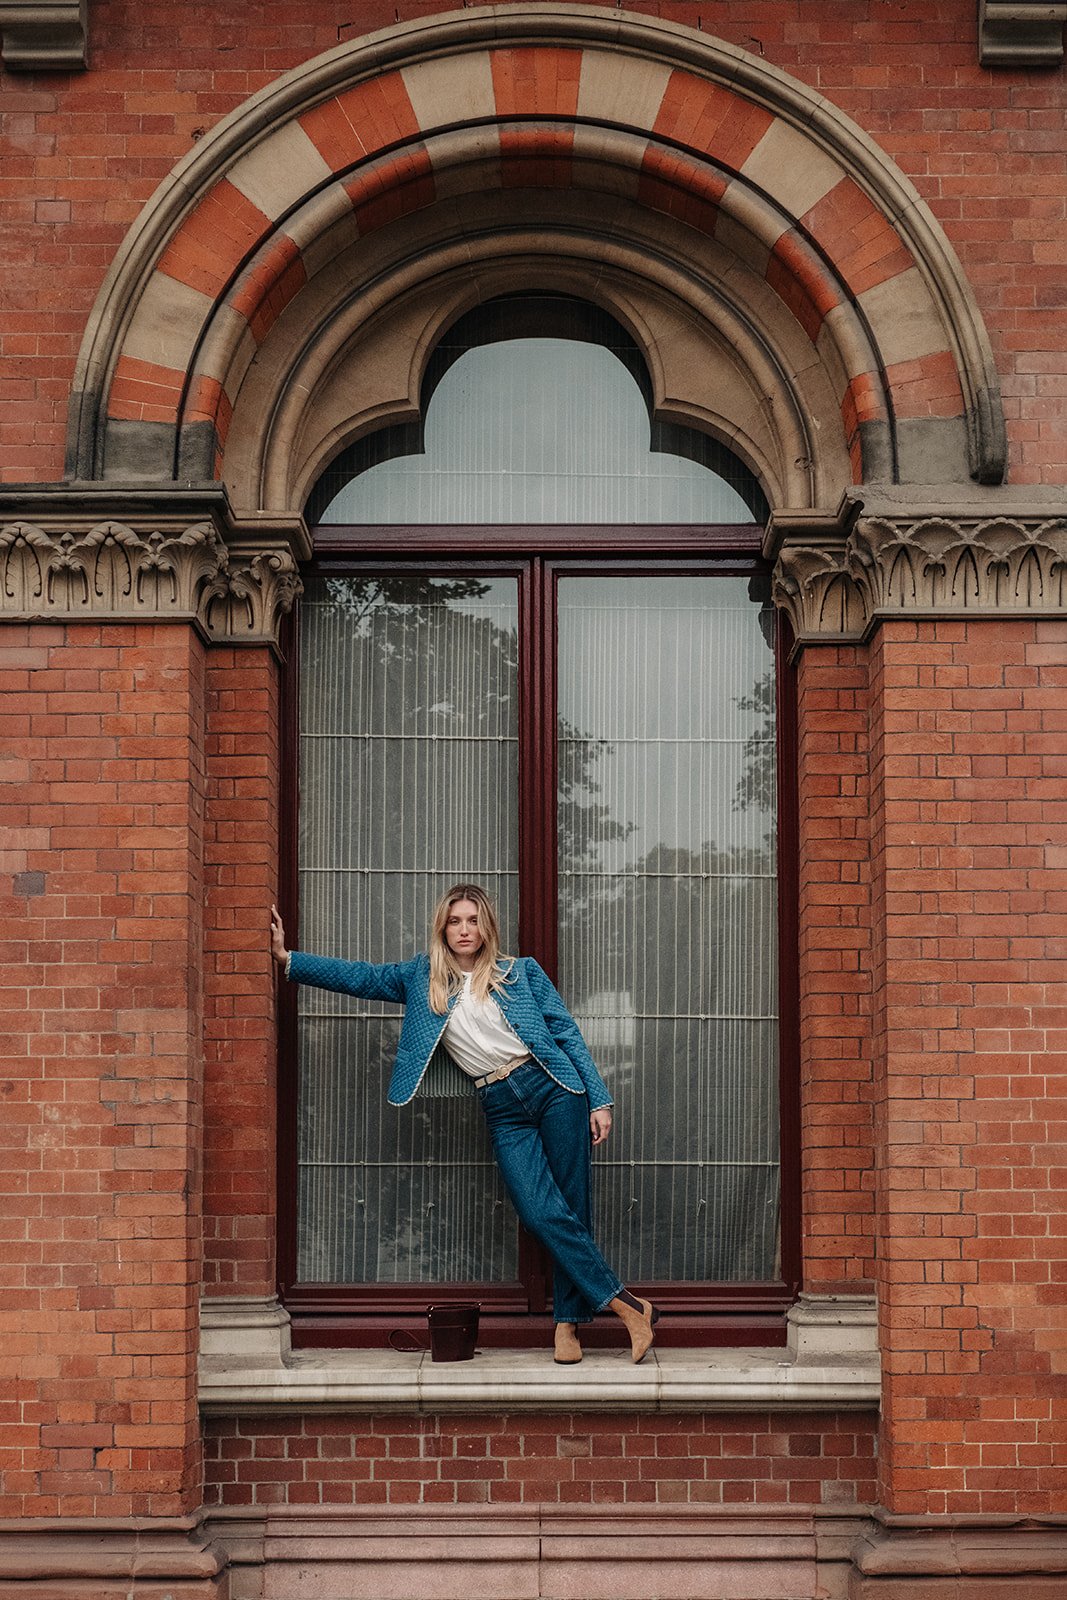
[72,5,1005,509]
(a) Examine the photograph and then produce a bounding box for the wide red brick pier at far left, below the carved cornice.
[0,624,203,1517]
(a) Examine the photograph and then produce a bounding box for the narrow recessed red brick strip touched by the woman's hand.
[203,646,280,1294]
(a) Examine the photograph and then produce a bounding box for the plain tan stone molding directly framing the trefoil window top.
[226,180,849,509]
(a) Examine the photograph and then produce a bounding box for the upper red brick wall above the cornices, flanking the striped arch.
[0,0,1067,483]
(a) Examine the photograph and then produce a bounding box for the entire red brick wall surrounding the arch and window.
[0,0,1067,1536]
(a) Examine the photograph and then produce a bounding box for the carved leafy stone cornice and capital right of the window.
[768,491,1067,645]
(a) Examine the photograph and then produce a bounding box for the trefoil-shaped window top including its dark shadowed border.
[307,294,766,525]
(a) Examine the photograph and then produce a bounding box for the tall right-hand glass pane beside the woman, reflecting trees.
[558,578,779,1282]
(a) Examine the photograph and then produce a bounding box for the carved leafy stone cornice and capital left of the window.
[0,485,307,643]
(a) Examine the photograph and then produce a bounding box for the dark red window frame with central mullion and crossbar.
[278,525,801,1347]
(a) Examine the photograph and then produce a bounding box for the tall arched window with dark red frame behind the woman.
[283,296,795,1338]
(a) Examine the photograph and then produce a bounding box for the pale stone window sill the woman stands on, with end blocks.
[200,1296,880,1414]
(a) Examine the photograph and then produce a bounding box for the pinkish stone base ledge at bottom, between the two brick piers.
[206,1502,870,1600]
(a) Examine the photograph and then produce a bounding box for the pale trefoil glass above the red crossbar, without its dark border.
[318,338,752,523]
